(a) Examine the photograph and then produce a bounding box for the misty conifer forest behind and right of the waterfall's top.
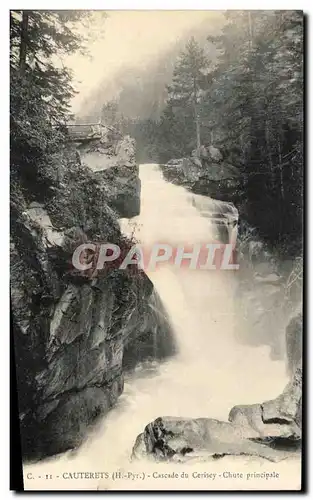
[102,11,303,256]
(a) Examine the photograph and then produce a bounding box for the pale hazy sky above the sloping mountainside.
[65,11,221,112]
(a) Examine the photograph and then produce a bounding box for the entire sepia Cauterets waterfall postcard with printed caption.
[9,8,305,492]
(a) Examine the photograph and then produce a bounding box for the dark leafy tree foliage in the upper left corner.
[10,11,88,198]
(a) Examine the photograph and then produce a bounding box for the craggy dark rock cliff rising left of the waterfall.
[11,142,174,459]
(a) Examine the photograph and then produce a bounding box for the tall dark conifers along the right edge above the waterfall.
[202,11,303,253]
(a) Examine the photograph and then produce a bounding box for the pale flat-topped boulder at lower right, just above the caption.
[132,368,302,462]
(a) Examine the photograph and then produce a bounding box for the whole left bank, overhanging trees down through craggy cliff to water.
[10,11,174,459]
